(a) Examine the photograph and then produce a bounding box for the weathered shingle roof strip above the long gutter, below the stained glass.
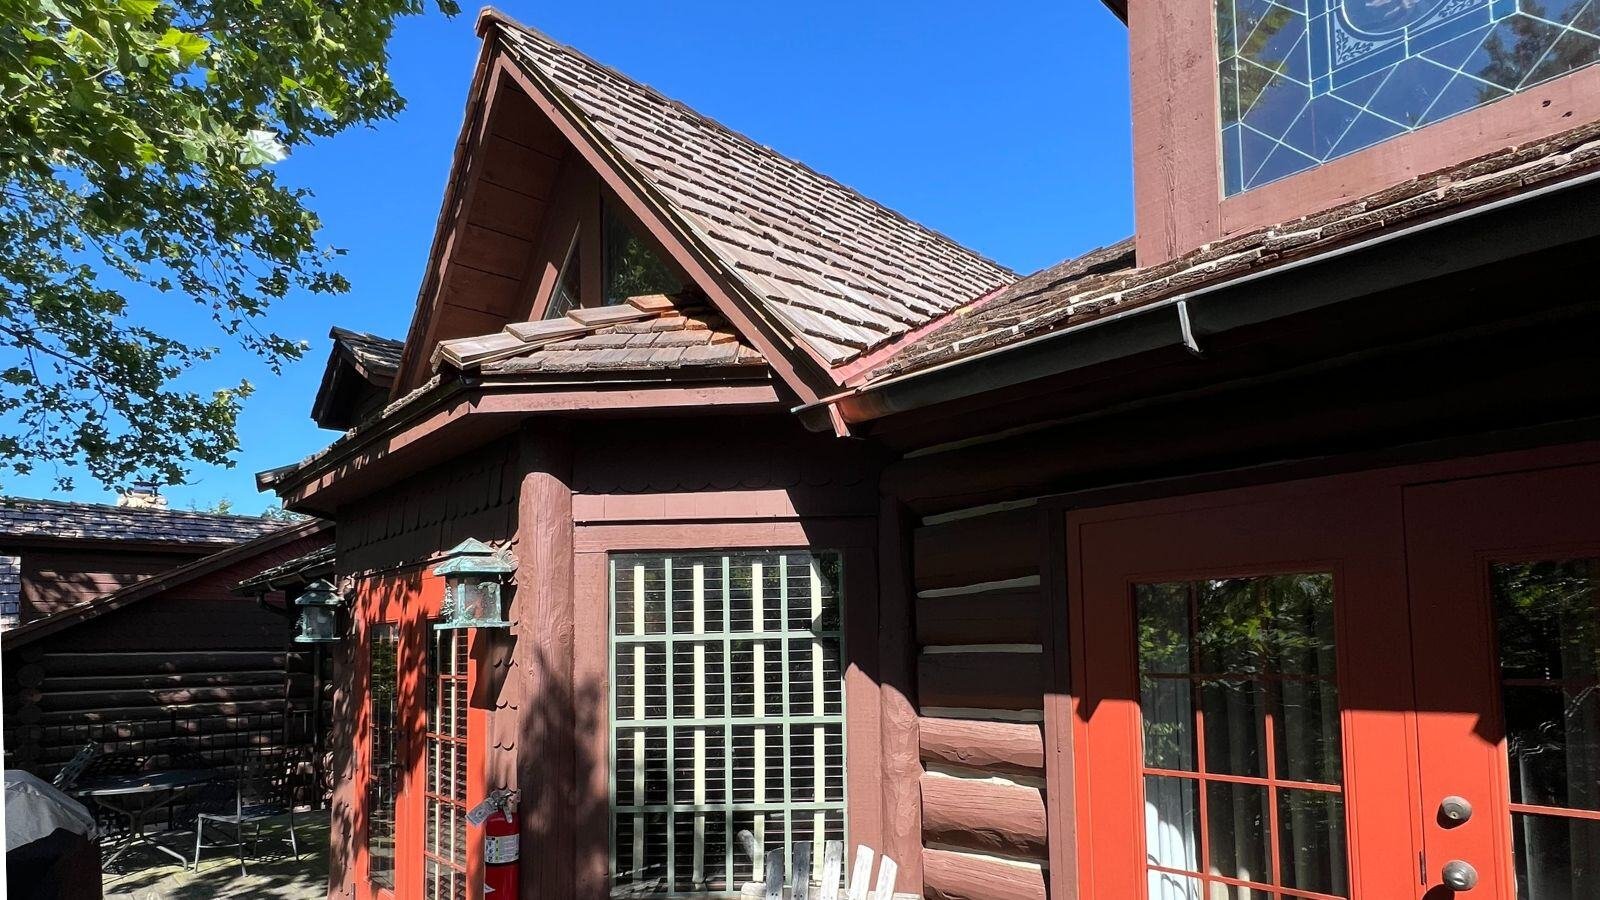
[867,122,1600,381]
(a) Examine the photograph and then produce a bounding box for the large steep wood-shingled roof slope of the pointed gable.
[485,11,1016,365]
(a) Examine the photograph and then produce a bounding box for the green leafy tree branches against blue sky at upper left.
[0,0,456,487]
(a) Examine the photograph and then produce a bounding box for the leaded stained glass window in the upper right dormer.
[1216,0,1600,195]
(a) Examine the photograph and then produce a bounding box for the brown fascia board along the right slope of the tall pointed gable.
[480,45,840,402]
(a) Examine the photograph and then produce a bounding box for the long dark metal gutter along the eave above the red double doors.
[792,171,1600,432]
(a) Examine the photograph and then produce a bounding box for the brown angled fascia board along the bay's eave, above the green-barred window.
[272,372,789,512]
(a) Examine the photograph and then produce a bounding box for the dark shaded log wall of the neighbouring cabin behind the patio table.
[3,536,326,791]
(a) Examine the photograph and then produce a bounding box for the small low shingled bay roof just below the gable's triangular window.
[434,295,766,376]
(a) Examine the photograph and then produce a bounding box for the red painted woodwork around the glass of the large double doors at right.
[1046,444,1600,900]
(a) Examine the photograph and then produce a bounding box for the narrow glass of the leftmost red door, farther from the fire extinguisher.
[366,621,400,890]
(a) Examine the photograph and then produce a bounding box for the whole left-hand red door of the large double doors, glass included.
[1067,485,1419,900]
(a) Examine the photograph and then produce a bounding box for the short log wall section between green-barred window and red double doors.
[912,506,1050,900]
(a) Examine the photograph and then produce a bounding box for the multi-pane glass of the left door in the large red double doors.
[1134,573,1349,900]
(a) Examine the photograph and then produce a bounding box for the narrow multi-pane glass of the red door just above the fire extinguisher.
[422,628,470,900]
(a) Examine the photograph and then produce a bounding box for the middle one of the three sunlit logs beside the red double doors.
[922,773,1050,863]
